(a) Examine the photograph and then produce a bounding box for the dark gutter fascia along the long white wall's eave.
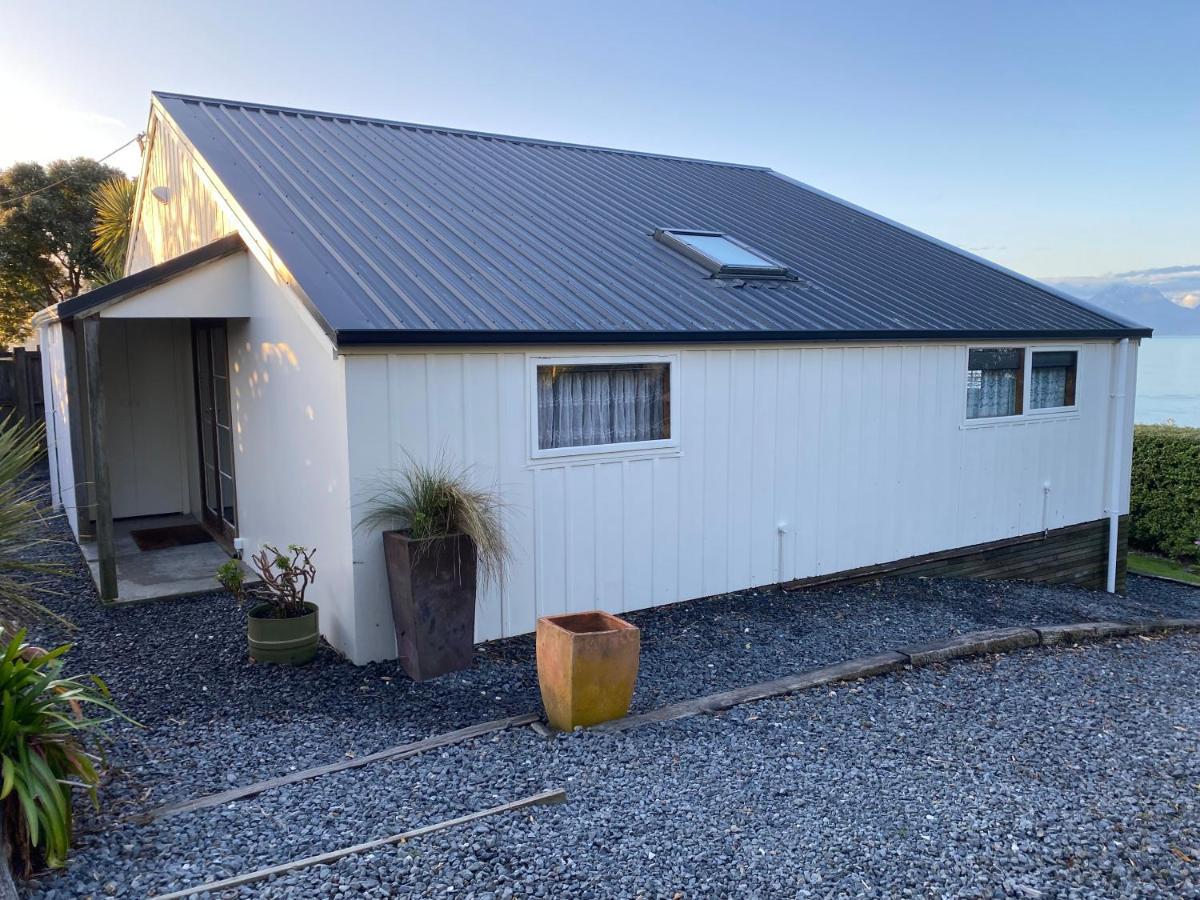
[336,328,1153,348]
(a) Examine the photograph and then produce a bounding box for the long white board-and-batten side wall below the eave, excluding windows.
[346,342,1136,658]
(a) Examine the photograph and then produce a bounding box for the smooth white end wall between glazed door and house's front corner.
[228,256,355,662]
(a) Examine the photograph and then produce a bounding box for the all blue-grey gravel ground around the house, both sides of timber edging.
[11,475,1200,898]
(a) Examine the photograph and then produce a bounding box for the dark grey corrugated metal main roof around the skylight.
[155,94,1148,343]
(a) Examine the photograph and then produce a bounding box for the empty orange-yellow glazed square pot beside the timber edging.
[538,610,642,731]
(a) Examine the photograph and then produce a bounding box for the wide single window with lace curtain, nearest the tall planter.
[538,362,671,450]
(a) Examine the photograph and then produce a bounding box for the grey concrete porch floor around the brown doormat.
[79,515,229,604]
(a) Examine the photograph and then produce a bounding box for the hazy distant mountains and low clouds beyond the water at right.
[1044,265,1200,336]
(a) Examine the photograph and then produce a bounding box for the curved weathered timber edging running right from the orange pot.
[587,618,1200,732]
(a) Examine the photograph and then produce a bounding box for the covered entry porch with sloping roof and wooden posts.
[37,235,247,604]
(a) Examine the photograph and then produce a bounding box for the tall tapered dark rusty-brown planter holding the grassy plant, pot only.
[383,532,475,682]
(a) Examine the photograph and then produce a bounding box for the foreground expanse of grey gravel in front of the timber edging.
[25,635,1200,898]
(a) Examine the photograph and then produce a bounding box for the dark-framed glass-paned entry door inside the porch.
[192,322,238,544]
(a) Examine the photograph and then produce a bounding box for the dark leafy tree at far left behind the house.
[0,157,124,344]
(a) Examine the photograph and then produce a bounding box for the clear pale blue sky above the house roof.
[0,0,1200,277]
